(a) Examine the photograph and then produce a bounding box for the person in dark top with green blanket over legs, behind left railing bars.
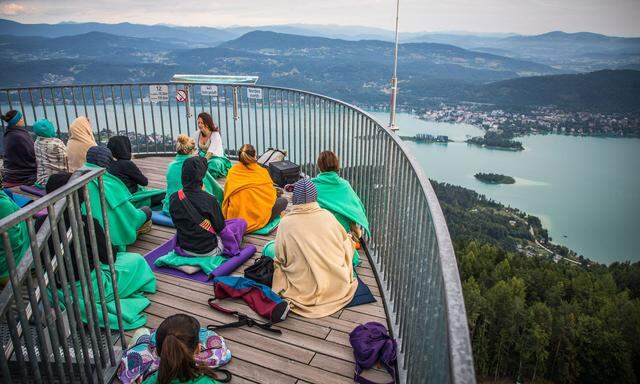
[52,216,156,330]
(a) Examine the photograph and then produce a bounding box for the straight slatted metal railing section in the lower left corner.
[0,169,125,383]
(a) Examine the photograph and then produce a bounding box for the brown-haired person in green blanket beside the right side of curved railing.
[311,151,370,265]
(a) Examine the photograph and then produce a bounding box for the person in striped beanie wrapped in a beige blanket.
[272,179,358,318]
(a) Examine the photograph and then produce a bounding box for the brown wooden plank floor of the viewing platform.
[123,157,389,383]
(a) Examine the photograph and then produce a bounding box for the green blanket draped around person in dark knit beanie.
[82,164,147,247]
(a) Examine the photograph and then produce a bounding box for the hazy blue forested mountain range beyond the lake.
[0,20,640,110]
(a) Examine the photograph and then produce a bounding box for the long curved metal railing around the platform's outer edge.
[0,83,475,383]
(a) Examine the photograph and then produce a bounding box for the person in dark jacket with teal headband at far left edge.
[2,110,36,187]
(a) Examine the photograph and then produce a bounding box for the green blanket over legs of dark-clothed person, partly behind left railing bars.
[58,252,156,330]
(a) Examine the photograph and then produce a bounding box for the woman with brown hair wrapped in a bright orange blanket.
[222,144,287,232]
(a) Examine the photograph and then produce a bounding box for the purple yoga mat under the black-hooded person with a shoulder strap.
[144,236,256,284]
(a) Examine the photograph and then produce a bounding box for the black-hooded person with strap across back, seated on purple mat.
[169,156,225,256]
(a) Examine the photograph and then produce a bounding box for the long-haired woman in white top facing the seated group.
[193,112,231,179]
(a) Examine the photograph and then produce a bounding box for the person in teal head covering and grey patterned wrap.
[33,119,69,188]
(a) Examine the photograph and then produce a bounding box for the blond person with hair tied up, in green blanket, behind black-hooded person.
[162,135,224,216]
